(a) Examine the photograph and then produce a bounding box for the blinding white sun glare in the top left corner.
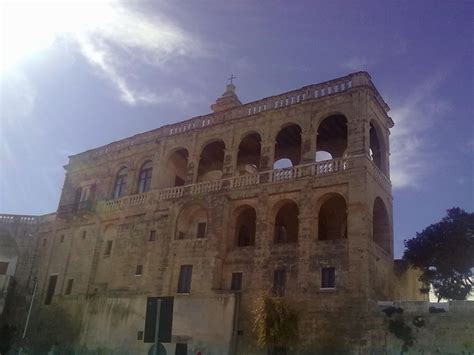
[0,1,114,73]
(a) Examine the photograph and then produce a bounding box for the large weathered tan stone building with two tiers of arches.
[0,72,430,354]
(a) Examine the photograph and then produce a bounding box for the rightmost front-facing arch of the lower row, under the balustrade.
[318,193,347,240]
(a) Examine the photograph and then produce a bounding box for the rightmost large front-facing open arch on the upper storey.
[316,114,347,159]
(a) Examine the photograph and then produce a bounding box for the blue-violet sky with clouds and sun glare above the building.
[0,0,474,256]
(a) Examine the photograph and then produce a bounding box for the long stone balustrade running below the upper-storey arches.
[97,158,356,212]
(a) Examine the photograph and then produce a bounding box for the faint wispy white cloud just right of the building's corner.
[390,75,451,188]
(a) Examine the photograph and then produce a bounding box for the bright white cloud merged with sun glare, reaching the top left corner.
[0,0,206,105]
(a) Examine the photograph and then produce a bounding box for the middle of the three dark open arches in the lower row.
[273,201,299,243]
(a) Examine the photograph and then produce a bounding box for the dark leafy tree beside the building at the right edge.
[403,207,474,302]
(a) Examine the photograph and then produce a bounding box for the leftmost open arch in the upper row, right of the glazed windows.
[161,147,189,188]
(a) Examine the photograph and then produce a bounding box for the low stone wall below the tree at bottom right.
[363,301,474,354]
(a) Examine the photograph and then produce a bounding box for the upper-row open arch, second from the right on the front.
[274,123,302,166]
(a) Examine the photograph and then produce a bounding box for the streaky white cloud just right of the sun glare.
[76,4,203,105]
